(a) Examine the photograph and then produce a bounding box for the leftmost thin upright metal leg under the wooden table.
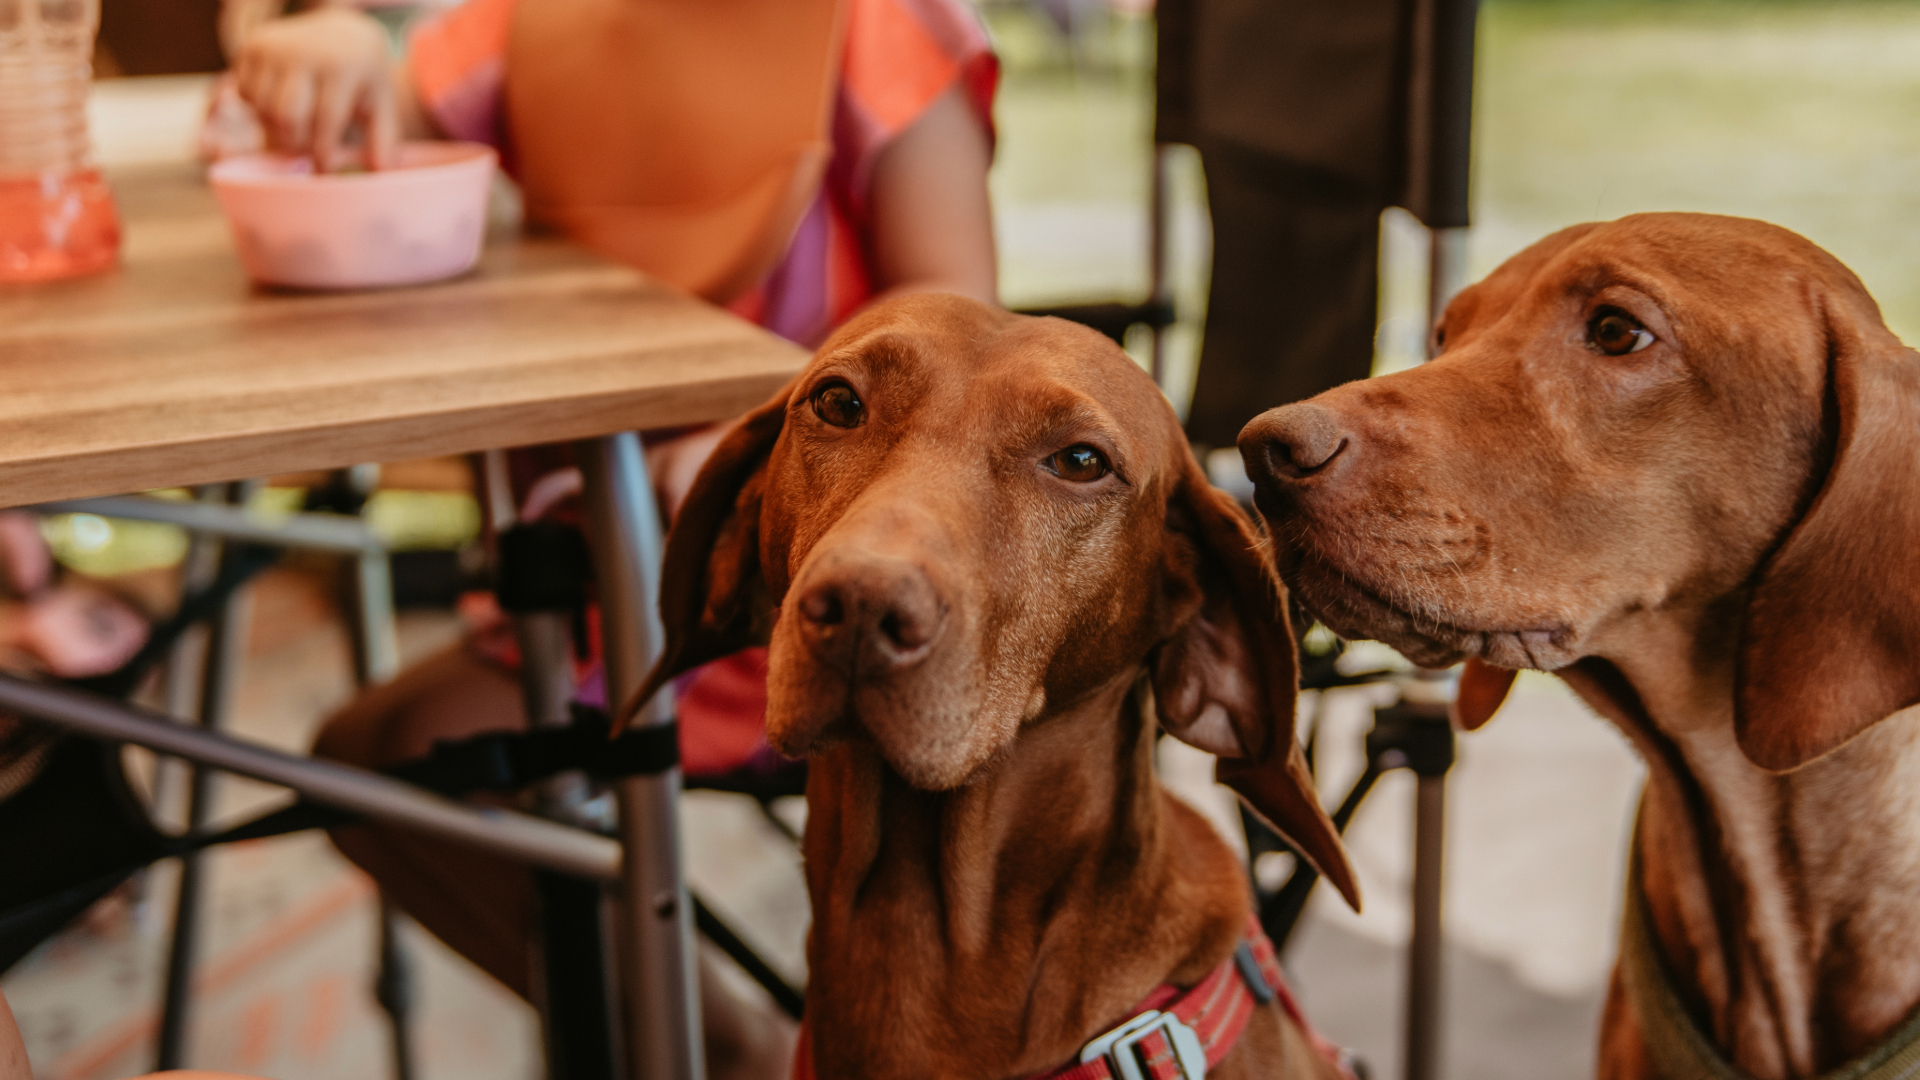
[154,480,253,1072]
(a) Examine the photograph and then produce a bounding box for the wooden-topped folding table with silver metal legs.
[0,167,804,1080]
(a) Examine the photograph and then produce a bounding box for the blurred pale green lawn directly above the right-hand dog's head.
[1471,0,1920,340]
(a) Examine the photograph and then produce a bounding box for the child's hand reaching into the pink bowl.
[234,8,399,171]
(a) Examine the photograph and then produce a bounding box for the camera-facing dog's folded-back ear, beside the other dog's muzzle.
[1152,465,1359,911]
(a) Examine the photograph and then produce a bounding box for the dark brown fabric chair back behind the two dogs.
[1156,0,1413,446]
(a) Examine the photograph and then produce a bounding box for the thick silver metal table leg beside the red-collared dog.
[576,432,707,1080]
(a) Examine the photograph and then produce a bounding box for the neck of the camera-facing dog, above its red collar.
[804,680,1250,1078]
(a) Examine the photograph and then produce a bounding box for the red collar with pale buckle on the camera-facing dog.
[793,917,1344,1080]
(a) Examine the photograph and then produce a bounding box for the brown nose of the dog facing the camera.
[795,552,947,676]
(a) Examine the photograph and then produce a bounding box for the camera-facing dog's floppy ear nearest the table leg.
[616,382,793,726]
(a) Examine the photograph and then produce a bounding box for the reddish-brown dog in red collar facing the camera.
[643,296,1354,1080]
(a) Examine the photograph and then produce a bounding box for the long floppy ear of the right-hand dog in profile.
[1734,282,1920,771]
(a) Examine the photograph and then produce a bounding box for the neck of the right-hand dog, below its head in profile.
[1563,598,1920,1080]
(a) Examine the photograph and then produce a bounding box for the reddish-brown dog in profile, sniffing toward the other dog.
[1240,213,1920,1080]
